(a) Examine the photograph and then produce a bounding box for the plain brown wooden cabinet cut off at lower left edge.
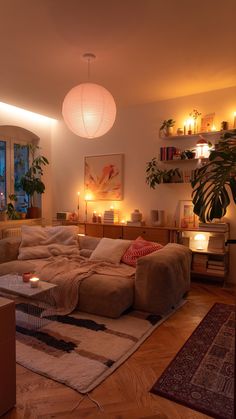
[0,297,16,416]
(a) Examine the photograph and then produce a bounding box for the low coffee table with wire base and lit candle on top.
[0,274,58,329]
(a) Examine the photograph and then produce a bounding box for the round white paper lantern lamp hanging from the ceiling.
[62,83,116,138]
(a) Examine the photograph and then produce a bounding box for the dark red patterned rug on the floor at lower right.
[151,303,235,419]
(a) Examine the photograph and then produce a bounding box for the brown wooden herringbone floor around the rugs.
[4,282,235,419]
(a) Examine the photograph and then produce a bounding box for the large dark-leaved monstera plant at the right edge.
[191,130,236,222]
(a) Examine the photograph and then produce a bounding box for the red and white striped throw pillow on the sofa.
[121,237,163,266]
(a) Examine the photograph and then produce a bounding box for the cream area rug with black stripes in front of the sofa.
[16,303,183,393]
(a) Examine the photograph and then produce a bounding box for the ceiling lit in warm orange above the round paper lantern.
[0,0,236,118]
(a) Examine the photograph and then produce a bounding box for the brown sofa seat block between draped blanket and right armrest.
[78,274,134,318]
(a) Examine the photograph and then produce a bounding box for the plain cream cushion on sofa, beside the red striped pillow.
[89,237,131,263]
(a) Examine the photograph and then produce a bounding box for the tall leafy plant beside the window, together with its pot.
[20,144,49,218]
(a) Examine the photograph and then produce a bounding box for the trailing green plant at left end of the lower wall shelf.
[146,157,182,189]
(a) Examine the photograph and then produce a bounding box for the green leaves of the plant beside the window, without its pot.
[20,144,49,205]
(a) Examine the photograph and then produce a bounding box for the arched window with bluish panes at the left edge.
[0,125,39,212]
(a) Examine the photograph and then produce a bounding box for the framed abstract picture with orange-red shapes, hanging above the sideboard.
[84,154,124,201]
